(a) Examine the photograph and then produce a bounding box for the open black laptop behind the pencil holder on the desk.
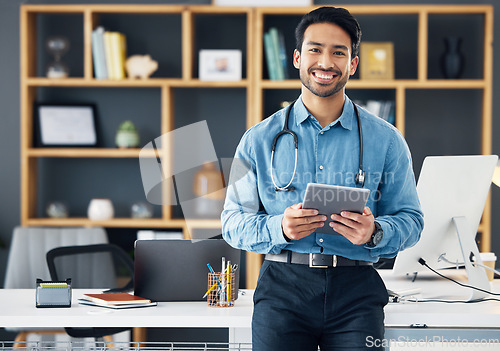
[134,239,241,301]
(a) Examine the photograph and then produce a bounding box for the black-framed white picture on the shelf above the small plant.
[35,104,97,147]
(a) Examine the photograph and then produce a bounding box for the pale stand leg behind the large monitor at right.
[453,216,491,301]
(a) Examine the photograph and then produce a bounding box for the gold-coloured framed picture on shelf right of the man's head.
[359,42,394,79]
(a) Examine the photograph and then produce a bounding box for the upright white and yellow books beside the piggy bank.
[92,26,127,79]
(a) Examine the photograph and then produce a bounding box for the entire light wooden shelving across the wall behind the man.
[20,5,493,288]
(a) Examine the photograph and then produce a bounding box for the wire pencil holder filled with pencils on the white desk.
[207,272,234,307]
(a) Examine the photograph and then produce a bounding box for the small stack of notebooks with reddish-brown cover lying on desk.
[78,293,157,309]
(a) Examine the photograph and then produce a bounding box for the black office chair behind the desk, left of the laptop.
[46,244,134,339]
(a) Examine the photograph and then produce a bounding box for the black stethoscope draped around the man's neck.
[271,101,365,191]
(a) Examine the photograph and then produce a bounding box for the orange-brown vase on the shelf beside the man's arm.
[193,162,225,218]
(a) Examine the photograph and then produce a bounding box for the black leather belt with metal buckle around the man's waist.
[266,251,373,268]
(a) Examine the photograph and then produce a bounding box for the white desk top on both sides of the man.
[0,271,500,329]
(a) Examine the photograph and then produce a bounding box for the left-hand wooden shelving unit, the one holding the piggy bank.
[21,5,253,228]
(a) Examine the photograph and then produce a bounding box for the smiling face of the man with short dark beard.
[293,23,359,97]
